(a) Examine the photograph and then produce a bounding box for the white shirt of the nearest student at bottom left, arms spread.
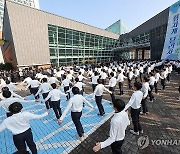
[0,112,48,135]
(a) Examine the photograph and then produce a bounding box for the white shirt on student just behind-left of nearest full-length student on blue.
[45,89,66,101]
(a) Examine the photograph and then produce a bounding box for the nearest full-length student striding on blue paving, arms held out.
[60,87,94,141]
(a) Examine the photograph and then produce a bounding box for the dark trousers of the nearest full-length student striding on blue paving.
[71,111,84,137]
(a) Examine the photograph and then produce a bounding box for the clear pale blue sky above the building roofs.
[39,0,178,31]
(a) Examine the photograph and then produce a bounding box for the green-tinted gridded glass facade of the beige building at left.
[48,25,117,66]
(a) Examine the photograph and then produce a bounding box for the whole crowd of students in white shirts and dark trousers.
[0,61,180,154]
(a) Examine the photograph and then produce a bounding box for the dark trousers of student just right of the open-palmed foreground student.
[131,108,142,132]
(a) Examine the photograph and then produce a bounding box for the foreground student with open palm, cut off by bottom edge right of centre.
[93,99,130,154]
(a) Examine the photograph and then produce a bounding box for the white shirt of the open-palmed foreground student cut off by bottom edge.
[100,110,130,149]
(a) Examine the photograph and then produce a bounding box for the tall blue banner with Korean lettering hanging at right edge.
[161,1,180,60]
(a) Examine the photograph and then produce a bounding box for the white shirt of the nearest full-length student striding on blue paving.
[60,94,93,120]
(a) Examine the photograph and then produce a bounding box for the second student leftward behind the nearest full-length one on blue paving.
[35,78,52,110]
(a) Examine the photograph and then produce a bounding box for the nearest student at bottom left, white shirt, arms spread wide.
[0,102,48,154]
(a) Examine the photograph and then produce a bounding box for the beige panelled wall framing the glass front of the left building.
[4,1,119,65]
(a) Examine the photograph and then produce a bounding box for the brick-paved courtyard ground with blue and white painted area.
[0,73,180,154]
